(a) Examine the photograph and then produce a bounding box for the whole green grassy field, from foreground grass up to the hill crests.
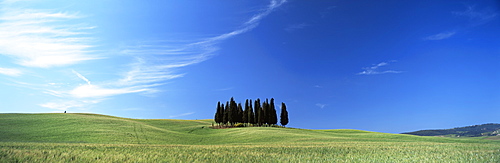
[0,114,500,162]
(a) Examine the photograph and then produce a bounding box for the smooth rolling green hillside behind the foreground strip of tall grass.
[0,114,492,145]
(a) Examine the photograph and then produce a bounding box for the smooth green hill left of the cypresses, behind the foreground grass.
[0,114,211,144]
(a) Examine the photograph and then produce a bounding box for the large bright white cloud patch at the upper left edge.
[0,2,99,67]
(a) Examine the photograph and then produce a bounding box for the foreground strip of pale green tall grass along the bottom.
[0,141,500,162]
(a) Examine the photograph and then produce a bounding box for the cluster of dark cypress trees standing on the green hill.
[214,97,288,127]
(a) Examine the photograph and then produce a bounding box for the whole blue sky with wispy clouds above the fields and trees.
[0,0,500,133]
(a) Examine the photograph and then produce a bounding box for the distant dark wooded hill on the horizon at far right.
[403,123,500,137]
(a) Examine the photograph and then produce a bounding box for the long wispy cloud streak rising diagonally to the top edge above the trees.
[117,0,286,94]
